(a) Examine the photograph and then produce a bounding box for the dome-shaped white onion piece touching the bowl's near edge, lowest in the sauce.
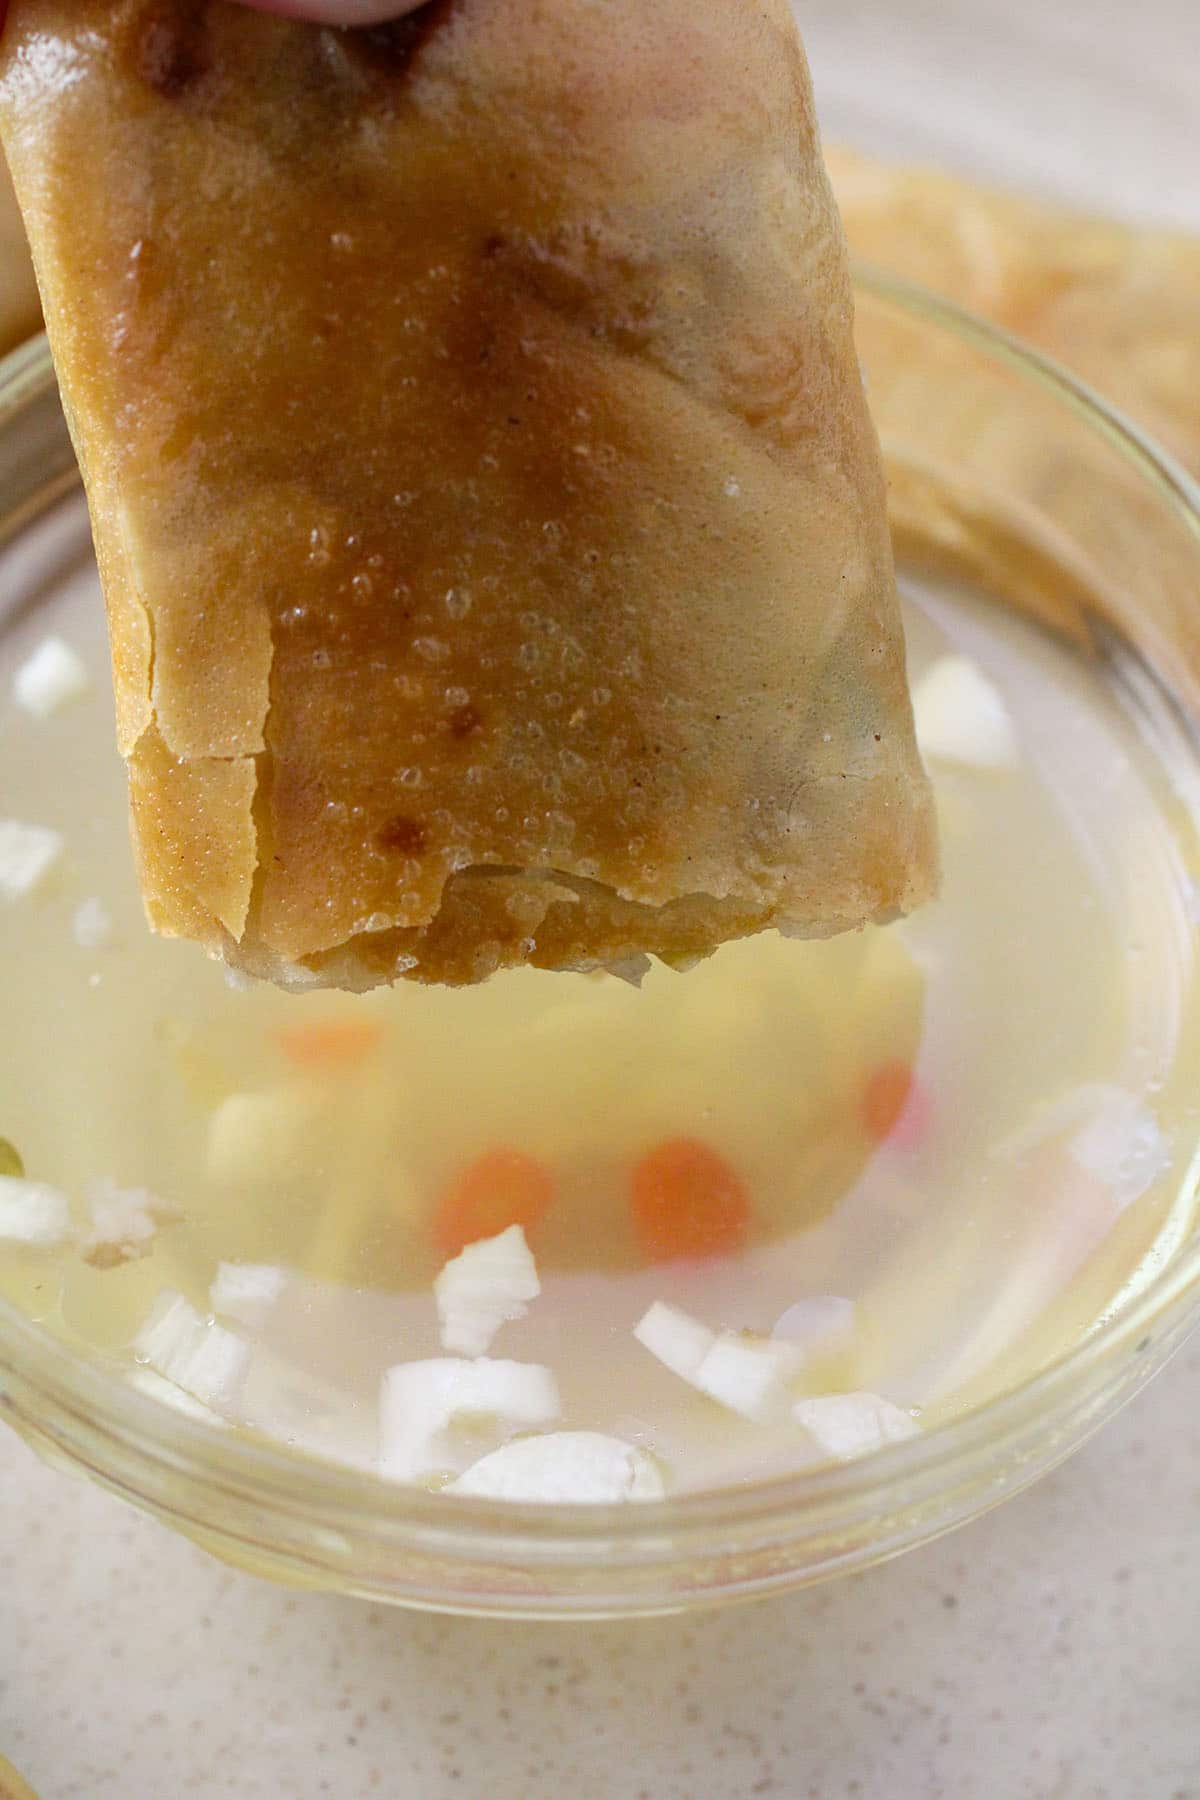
[448,1431,664,1505]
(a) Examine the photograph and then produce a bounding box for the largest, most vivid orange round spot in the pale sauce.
[630,1138,750,1262]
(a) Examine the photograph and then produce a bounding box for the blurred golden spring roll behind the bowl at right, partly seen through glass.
[829,151,1200,709]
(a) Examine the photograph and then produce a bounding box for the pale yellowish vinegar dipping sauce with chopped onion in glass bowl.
[0,500,1200,1498]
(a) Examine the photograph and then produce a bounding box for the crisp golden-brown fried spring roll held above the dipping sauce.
[0,0,936,986]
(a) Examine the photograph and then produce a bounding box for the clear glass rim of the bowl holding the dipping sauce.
[0,268,1200,1616]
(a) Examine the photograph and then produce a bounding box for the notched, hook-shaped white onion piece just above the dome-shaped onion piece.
[380,1357,561,1481]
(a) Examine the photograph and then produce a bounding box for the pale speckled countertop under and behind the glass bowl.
[0,0,1200,1800]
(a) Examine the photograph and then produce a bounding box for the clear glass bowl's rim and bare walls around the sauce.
[0,272,1200,1618]
